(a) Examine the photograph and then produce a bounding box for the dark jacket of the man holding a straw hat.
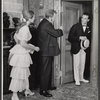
[68,23,90,54]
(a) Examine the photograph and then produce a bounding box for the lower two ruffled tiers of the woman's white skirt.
[9,67,30,92]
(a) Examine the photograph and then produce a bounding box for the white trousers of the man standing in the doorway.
[73,49,86,82]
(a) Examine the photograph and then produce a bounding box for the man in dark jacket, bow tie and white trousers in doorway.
[68,13,90,85]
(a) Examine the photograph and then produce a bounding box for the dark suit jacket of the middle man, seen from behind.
[37,18,63,56]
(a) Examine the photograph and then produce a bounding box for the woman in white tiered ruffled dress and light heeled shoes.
[9,11,39,100]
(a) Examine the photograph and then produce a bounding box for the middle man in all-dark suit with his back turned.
[37,9,63,97]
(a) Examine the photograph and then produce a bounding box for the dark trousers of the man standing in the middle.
[40,56,54,91]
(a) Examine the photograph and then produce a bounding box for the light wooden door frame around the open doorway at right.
[54,0,98,88]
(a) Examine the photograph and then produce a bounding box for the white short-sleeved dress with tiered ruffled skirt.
[9,25,33,92]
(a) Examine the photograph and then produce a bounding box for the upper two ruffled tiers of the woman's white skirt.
[9,44,33,67]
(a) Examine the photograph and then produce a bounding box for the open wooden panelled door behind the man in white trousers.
[61,1,82,83]
